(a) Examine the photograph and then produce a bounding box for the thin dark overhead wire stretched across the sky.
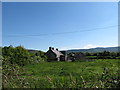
[3,25,120,37]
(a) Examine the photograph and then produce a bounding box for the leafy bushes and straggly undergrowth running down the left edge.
[0,46,47,87]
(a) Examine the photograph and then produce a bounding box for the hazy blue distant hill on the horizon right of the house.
[67,47,120,53]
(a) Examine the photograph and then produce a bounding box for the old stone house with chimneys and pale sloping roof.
[45,47,67,61]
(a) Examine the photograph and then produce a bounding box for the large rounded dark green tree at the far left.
[2,46,29,66]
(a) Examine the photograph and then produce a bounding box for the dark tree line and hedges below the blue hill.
[68,51,120,61]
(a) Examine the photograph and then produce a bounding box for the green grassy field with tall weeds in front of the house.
[3,59,120,88]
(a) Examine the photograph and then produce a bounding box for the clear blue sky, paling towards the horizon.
[2,2,118,51]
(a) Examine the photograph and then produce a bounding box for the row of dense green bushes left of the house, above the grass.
[2,46,47,66]
